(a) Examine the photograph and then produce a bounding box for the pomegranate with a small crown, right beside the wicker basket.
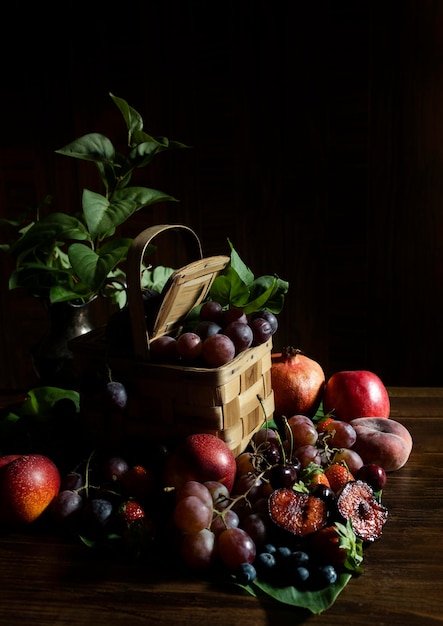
[271,347,325,418]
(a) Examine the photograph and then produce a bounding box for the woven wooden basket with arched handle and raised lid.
[71,225,274,455]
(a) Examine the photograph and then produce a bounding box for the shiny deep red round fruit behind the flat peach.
[323,370,391,422]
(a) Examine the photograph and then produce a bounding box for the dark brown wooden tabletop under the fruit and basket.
[0,388,443,626]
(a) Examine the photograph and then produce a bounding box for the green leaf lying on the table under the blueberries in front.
[240,574,352,613]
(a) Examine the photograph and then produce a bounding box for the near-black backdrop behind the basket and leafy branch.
[0,0,443,388]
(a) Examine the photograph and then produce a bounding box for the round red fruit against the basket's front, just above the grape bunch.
[164,433,237,492]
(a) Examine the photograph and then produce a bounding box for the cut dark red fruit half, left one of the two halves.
[269,488,328,537]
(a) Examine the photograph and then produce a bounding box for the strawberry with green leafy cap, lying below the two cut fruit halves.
[310,521,363,573]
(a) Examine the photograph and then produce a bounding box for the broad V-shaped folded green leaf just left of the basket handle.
[68,239,132,292]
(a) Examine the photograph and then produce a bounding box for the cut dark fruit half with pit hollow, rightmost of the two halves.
[337,480,388,542]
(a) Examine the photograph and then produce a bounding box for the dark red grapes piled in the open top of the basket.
[150,300,278,367]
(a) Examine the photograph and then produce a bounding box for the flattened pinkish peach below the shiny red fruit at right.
[350,417,412,472]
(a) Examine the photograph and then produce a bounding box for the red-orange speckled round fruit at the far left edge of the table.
[0,454,60,525]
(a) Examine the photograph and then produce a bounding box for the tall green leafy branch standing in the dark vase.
[0,94,187,307]
